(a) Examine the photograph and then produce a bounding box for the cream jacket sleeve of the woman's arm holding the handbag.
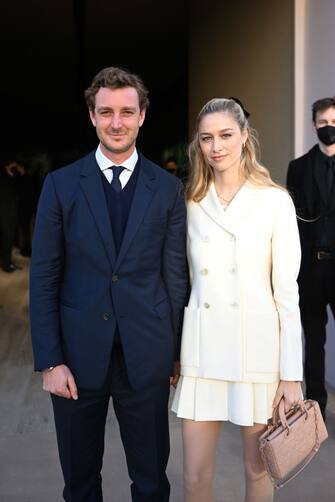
[272,193,303,381]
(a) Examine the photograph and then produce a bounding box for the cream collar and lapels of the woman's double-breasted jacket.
[199,183,258,235]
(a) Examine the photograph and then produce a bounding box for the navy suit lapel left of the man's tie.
[80,152,116,266]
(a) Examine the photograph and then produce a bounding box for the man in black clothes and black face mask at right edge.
[287,98,335,416]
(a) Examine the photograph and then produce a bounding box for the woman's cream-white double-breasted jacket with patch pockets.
[181,182,302,382]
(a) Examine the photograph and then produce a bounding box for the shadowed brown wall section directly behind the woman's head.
[189,0,294,182]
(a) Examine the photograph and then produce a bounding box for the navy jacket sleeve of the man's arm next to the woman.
[162,181,189,361]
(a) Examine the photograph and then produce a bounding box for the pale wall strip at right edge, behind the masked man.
[295,0,335,387]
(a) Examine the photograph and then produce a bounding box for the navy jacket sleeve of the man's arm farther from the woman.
[29,174,64,371]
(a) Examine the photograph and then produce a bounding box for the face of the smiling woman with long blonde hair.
[199,112,248,176]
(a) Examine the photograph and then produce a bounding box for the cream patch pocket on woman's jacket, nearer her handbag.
[244,311,279,373]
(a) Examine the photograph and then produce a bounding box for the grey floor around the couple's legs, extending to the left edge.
[0,253,335,502]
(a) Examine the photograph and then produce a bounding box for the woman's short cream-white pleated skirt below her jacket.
[172,376,279,426]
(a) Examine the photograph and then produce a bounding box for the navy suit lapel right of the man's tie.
[115,154,156,268]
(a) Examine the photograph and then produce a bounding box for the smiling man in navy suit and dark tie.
[30,68,188,502]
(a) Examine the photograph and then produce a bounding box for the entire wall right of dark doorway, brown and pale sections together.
[189,0,335,387]
